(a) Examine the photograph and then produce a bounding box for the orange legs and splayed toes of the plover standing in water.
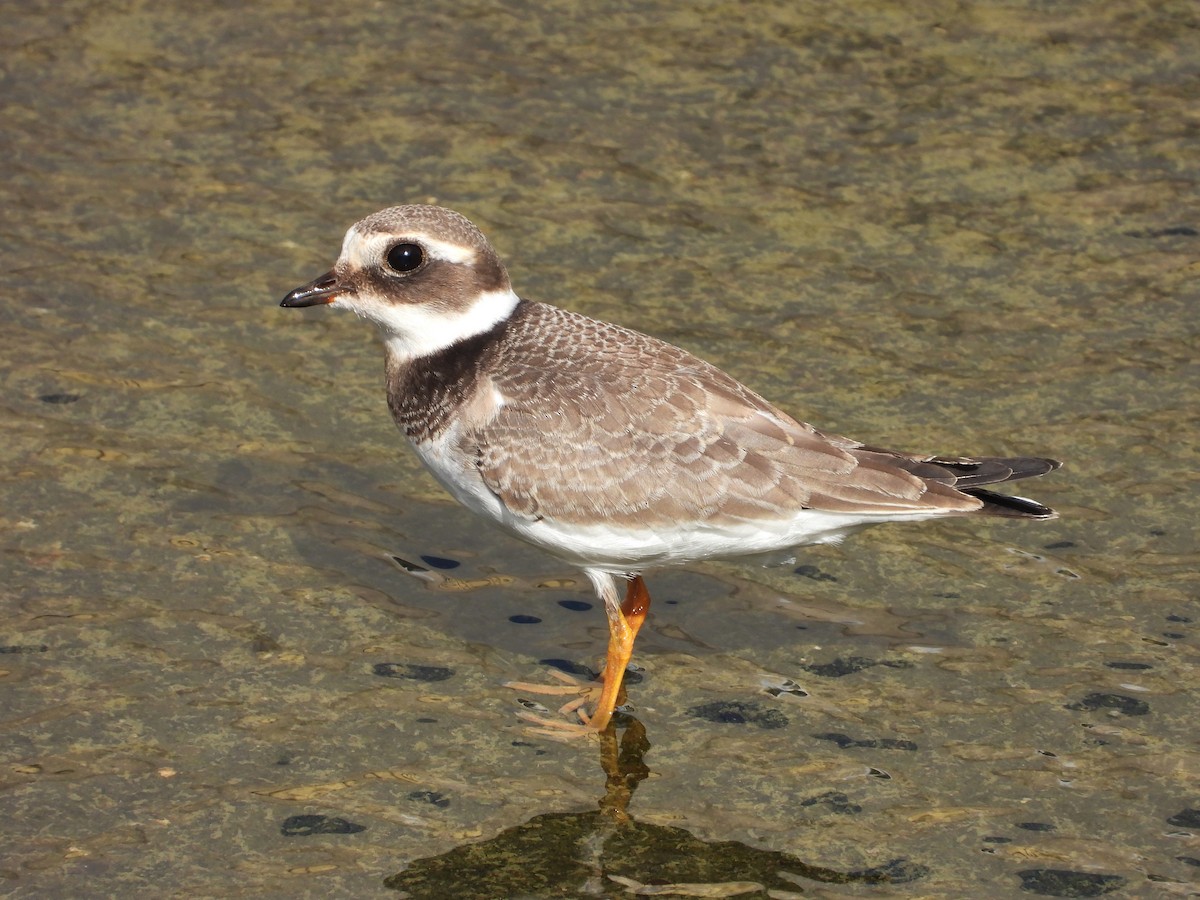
[508,574,650,737]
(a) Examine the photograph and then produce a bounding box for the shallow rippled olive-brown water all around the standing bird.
[0,0,1200,898]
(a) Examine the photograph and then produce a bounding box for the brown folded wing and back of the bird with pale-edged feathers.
[462,304,1027,526]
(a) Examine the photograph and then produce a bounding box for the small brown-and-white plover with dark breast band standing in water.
[282,206,1058,733]
